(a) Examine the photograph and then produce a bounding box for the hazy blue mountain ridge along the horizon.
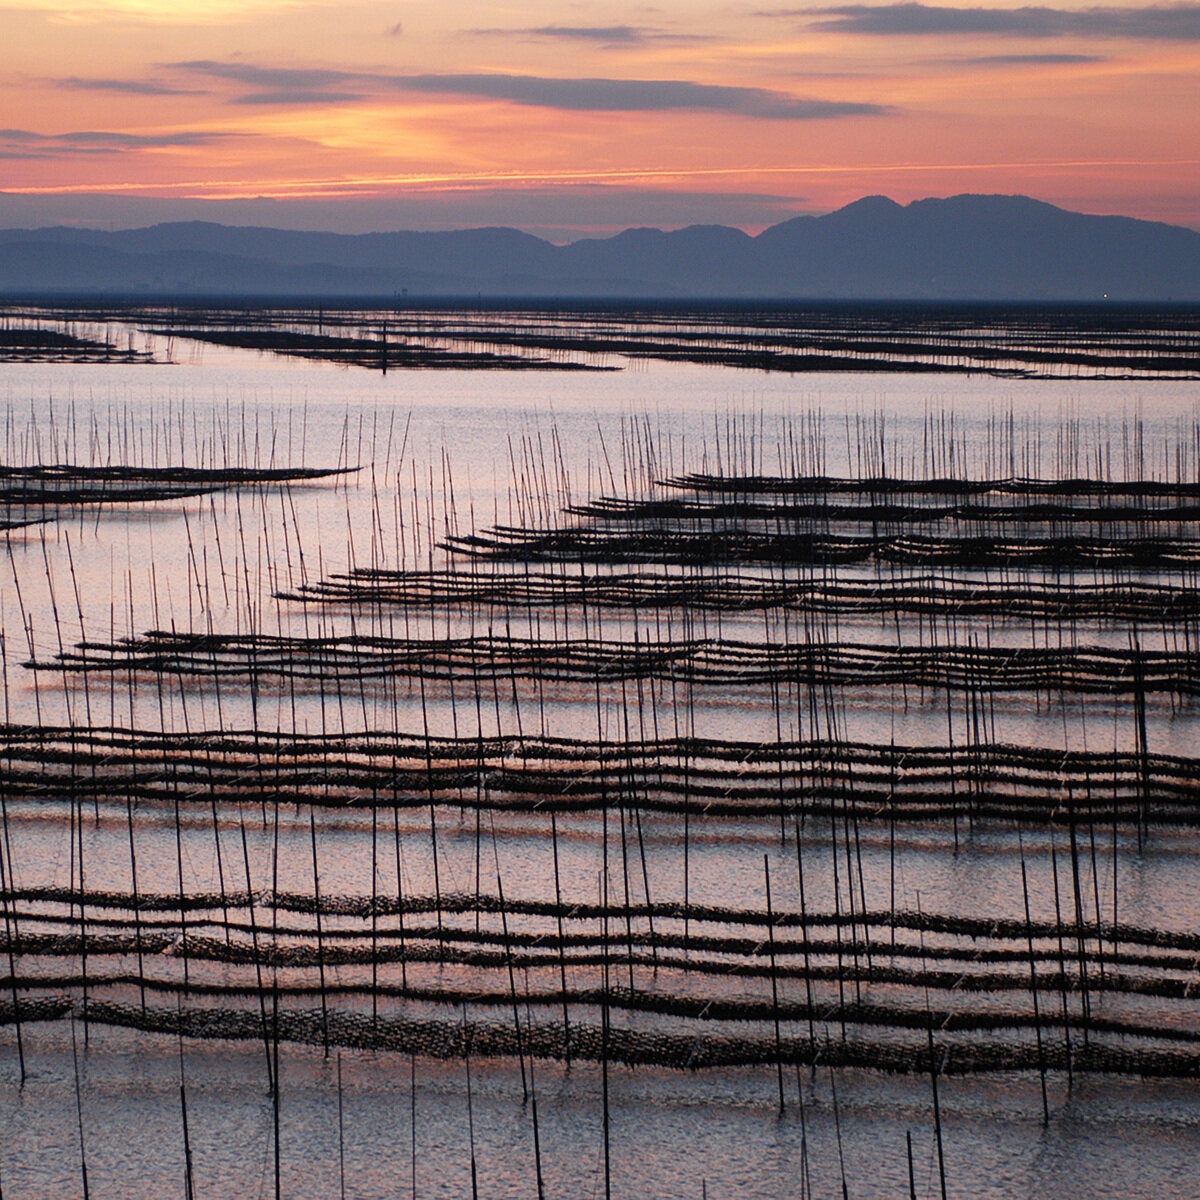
[0,196,1200,302]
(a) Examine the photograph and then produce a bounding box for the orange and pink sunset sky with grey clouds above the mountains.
[0,0,1200,241]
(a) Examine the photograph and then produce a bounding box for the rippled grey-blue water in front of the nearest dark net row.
[0,1028,1200,1200]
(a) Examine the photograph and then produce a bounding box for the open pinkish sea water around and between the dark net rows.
[0,324,1200,1200]
